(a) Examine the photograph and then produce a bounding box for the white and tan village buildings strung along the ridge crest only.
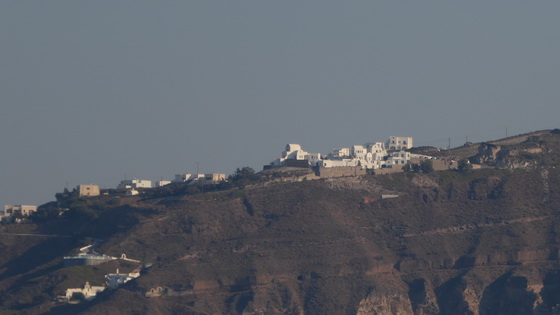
[0,136,457,223]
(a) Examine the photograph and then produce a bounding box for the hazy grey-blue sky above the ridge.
[0,0,560,205]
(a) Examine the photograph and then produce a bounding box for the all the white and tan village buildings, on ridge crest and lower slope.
[0,136,464,303]
